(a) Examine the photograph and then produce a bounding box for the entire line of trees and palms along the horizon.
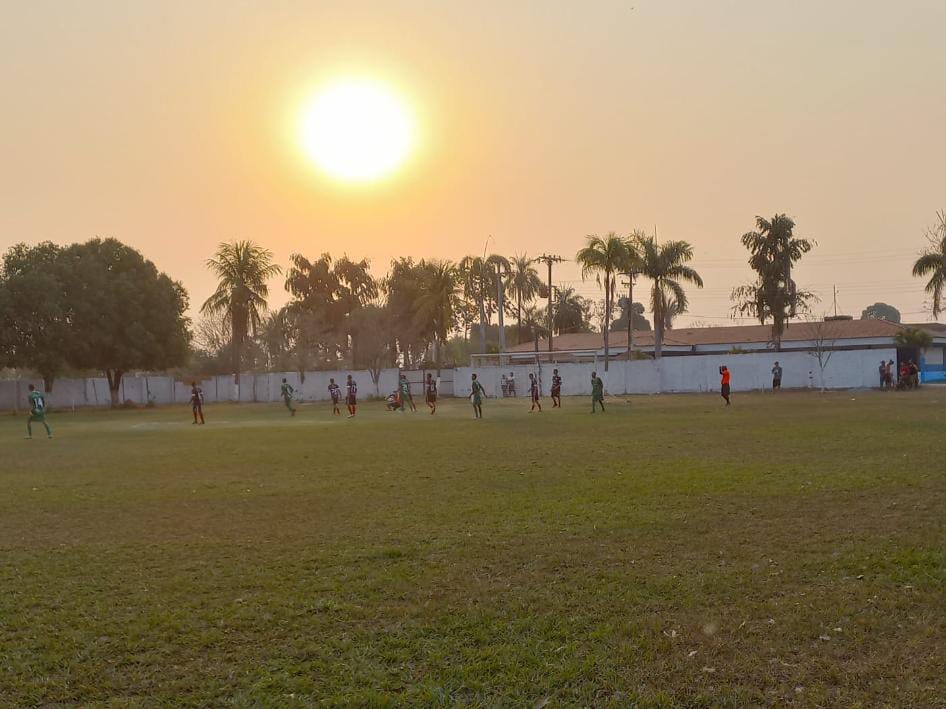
[0,207,946,404]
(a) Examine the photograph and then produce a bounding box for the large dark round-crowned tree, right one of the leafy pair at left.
[61,239,190,406]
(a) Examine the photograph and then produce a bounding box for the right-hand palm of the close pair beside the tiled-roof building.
[637,237,703,358]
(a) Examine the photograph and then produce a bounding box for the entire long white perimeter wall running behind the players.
[0,348,897,411]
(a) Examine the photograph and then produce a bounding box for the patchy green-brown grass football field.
[0,388,946,707]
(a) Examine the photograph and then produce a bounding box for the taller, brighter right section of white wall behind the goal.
[453,348,897,396]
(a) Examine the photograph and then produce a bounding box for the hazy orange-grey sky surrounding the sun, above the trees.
[0,0,946,324]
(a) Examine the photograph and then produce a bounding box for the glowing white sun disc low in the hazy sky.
[299,80,415,182]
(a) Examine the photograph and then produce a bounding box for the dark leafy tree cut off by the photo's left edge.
[0,242,76,392]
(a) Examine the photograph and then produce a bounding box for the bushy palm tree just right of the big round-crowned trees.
[200,241,281,385]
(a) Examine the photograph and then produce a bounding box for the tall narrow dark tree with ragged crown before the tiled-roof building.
[732,214,814,350]
